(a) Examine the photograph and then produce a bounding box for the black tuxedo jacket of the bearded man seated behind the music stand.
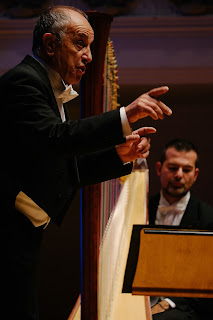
[149,193,213,320]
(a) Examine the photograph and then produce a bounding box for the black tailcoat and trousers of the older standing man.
[0,56,132,320]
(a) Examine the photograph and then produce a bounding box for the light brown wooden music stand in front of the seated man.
[132,228,213,298]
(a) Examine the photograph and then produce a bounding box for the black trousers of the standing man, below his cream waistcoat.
[0,209,43,320]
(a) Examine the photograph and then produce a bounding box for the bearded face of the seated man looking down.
[156,147,199,203]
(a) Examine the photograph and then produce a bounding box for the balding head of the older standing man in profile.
[33,6,94,85]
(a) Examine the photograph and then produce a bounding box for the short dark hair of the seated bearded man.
[160,138,199,168]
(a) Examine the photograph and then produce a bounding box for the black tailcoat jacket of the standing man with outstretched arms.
[0,56,132,224]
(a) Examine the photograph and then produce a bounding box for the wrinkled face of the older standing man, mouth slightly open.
[52,11,94,84]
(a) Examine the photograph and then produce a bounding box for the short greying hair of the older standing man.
[32,6,88,56]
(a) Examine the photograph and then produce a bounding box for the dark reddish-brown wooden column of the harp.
[81,12,112,320]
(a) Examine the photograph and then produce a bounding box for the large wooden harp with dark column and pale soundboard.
[68,12,151,320]
